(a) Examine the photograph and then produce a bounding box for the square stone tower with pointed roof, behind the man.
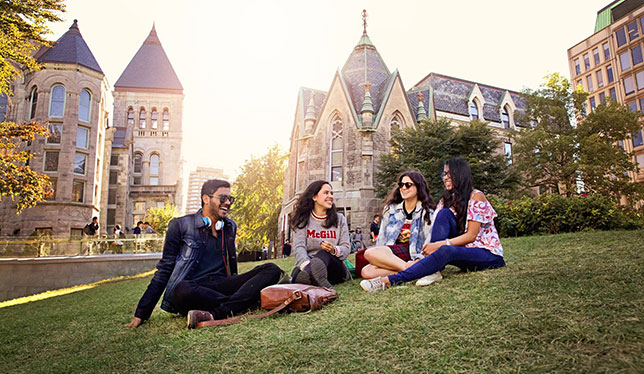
[103,26,184,232]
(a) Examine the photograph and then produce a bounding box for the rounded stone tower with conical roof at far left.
[0,20,109,236]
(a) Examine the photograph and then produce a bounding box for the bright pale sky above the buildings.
[49,0,610,179]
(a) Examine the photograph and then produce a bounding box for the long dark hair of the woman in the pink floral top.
[441,157,474,234]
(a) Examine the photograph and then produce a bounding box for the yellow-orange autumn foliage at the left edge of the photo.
[0,0,65,214]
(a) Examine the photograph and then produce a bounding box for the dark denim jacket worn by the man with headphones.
[134,209,237,320]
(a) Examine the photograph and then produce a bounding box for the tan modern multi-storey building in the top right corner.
[568,0,644,186]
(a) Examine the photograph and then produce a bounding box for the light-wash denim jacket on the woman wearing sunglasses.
[376,201,434,260]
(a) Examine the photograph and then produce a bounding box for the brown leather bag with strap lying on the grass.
[197,284,338,328]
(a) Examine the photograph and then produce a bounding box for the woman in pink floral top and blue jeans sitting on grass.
[360,158,505,292]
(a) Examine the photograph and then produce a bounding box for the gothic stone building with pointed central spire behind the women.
[279,22,525,241]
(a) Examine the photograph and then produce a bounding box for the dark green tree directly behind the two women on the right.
[376,119,518,197]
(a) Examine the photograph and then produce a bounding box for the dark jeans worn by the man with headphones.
[172,263,282,319]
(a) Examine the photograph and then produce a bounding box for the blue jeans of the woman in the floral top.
[389,209,505,285]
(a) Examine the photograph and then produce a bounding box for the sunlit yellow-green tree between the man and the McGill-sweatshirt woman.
[230,145,286,253]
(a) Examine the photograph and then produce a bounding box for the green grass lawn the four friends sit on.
[0,231,644,373]
